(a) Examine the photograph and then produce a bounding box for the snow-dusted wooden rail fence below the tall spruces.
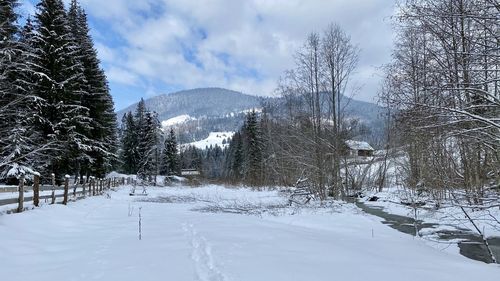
[0,174,131,212]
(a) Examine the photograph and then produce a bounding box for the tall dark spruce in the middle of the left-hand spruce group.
[32,0,92,179]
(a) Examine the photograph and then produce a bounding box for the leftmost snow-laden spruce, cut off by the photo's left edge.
[0,0,49,178]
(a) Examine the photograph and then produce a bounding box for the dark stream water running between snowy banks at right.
[354,200,500,263]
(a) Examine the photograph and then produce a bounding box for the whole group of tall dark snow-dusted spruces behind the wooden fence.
[0,0,117,183]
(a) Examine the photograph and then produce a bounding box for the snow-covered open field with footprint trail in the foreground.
[0,186,500,281]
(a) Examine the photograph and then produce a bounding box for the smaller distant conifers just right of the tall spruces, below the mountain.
[119,99,232,183]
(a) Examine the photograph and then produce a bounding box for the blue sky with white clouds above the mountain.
[21,0,394,110]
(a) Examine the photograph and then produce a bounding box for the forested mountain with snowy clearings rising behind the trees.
[117,88,384,143]
